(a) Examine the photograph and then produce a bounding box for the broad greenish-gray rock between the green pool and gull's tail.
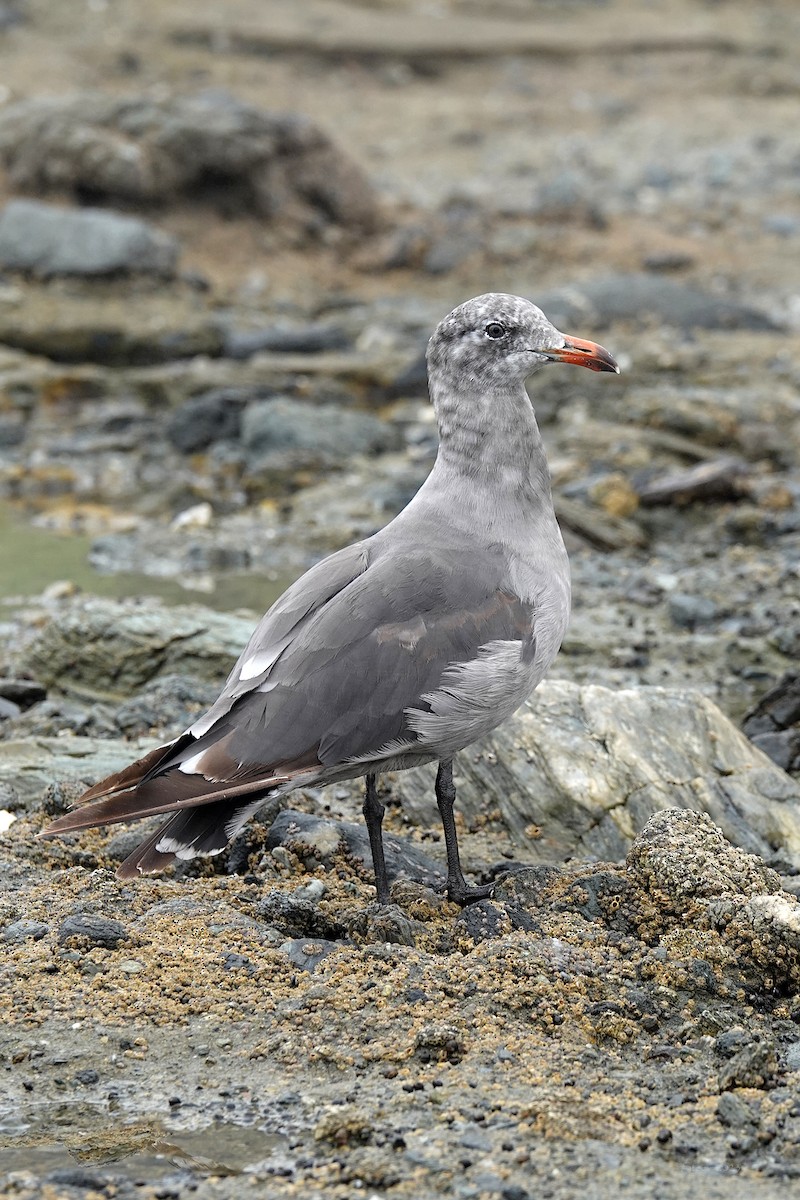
[15,598,253,700]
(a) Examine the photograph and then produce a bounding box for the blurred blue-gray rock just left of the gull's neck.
[241,396,398,463]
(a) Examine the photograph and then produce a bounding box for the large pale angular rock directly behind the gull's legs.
[390,679,800,866]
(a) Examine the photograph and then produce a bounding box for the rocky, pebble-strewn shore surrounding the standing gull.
[0,0,800,1200]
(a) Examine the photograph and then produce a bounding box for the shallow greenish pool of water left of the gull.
[0,504,291,612]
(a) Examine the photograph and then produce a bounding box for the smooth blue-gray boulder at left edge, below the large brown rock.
[0,200,178,277]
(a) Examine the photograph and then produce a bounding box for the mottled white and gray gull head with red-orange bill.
[427,292,619,391]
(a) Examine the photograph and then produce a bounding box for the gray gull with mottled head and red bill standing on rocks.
[44,294,619,905]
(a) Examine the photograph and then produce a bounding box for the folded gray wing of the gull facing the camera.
[167,542,534,784]
